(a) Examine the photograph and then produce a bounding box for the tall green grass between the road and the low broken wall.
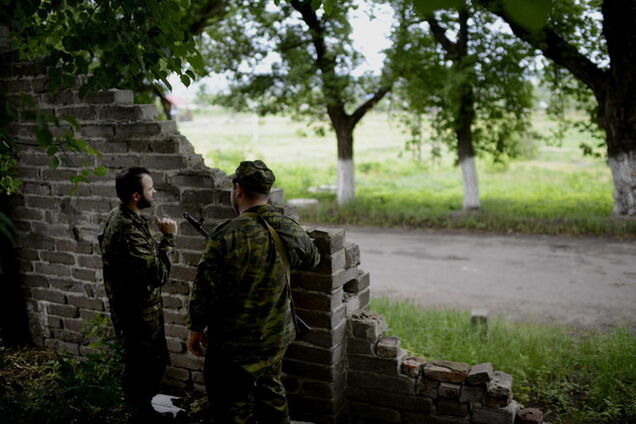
[371,299,636,424]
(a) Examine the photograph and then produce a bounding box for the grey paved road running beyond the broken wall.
[346,228,636,328]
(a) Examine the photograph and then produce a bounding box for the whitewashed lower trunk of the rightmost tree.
[609,152,636,216]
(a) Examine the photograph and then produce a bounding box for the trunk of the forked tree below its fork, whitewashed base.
[332,120,355,206]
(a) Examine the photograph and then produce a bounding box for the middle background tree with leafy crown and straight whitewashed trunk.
[390,1,533,210]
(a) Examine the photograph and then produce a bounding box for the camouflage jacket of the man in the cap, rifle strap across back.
[189,205,320,371]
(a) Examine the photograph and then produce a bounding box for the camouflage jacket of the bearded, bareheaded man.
[100,205,174,341]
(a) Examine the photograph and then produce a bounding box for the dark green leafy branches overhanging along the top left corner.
[0,0,203,97]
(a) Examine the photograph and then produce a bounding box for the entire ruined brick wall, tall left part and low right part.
[0,28,538,424]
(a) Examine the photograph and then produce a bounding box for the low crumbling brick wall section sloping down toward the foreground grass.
[347,311,543,424]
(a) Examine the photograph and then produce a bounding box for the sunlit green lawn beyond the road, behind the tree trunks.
[180,108,636,237]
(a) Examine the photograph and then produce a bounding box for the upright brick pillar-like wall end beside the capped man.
[283,229,370,424]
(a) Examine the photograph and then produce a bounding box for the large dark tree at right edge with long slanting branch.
[477,0,636,217]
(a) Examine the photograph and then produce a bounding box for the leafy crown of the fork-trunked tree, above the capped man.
[201,0,380,119]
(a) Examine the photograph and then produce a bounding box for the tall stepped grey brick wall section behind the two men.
[0,55,234,368]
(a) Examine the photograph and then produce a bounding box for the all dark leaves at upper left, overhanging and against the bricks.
[0,0,203,193]
